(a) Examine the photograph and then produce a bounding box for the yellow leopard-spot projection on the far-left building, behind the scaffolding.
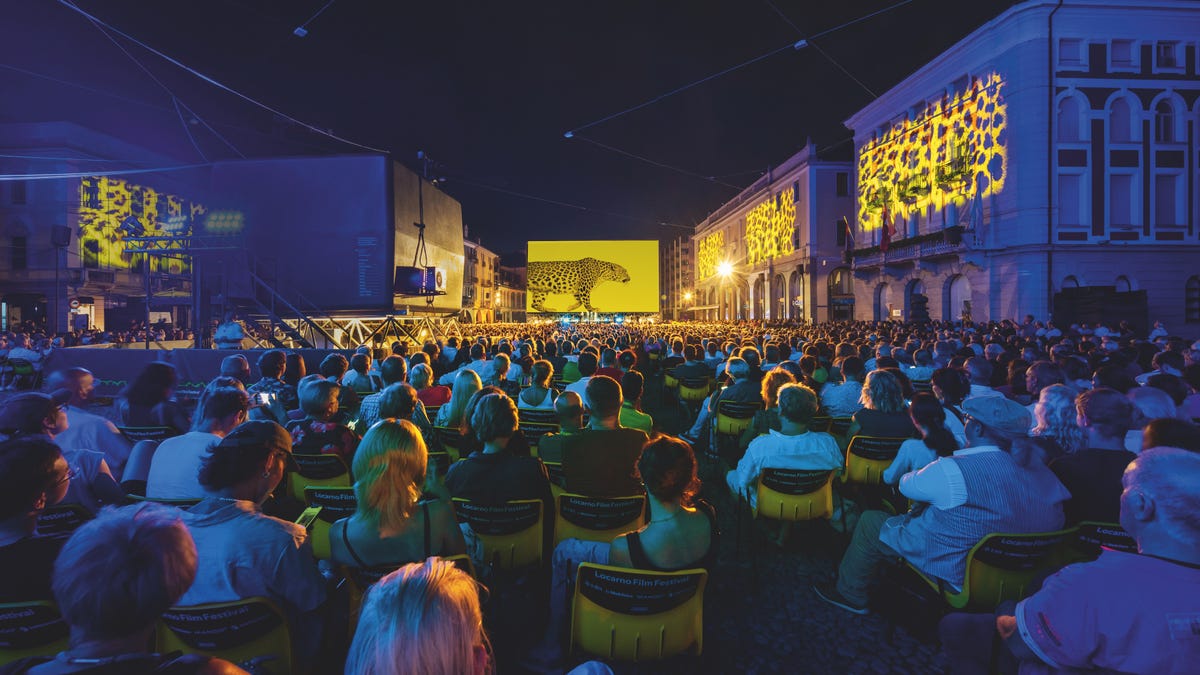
[78,177,206,271]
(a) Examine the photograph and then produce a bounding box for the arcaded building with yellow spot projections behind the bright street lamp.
[691,143,854,322]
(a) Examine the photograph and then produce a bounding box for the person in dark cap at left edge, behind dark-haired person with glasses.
[0,389,125,513]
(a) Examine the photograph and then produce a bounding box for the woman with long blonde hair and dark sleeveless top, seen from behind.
[329,419,467,569]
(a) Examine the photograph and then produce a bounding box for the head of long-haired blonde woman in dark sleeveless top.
[352,419,428,537]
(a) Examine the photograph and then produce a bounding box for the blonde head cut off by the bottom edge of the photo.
[346,557,490,675]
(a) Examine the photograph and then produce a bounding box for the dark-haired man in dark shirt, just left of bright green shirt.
[563,376,647,497]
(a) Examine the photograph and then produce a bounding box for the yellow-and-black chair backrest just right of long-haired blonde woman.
[454,497,544,569]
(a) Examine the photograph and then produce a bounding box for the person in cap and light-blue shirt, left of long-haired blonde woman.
[179,420,325,663]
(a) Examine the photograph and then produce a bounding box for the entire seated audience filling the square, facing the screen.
[0,317,1200,674]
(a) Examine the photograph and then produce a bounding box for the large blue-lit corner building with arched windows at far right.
[846,0,1200,326]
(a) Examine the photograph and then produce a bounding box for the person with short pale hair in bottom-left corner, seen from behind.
[5,504,246,675]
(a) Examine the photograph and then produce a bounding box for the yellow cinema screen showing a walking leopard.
[526,241,659,312]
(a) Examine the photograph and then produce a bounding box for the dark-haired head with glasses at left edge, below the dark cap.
[0,436,71,523]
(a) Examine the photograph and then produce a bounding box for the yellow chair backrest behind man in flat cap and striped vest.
[946,530,1074,611]
